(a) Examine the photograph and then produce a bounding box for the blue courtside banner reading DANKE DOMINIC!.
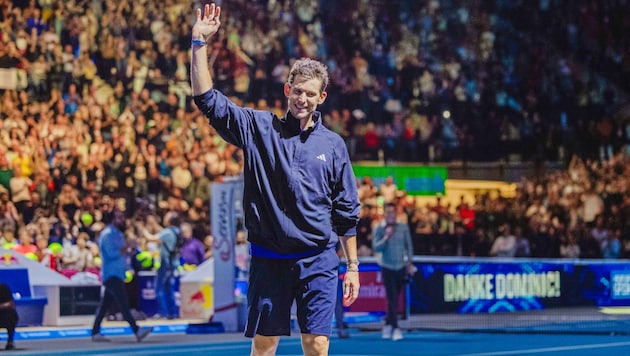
[409,258,630,314]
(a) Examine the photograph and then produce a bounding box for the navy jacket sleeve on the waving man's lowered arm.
[332,141,361,236]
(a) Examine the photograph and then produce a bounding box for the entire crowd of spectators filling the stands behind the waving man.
[0,0,630,275]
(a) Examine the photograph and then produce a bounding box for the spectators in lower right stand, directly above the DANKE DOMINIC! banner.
[357,153,630,259]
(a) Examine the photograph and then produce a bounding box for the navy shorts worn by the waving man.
[245,248,339,337]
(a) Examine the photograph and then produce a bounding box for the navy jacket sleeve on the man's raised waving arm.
[194,89,260,148]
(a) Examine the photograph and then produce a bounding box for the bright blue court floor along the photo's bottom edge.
[7,329,630,356]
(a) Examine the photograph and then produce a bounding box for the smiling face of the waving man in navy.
[284,75,327,120]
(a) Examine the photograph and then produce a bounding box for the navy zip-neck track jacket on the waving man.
[194,89,359,258]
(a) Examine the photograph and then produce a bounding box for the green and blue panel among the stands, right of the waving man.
[352,165,447,195]
